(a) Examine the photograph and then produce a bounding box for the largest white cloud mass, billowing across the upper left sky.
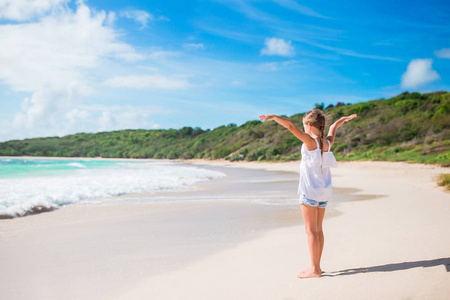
[0,1,143,138]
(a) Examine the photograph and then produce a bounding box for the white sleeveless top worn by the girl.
[298,138,337,201]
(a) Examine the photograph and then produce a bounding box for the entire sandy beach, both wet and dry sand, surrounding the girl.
[0,161,450,299]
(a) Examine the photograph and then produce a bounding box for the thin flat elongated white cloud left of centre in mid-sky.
[103,75,189,89]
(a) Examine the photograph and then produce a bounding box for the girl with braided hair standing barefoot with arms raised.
[259,109,357,278]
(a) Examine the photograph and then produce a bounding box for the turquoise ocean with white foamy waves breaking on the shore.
[0,158,225,218]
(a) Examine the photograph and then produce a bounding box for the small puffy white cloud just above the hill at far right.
[400,59,441,88]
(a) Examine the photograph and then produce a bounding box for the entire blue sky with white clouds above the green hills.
[0,0,450,141]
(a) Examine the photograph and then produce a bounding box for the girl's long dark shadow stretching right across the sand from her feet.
[322,257,450,277]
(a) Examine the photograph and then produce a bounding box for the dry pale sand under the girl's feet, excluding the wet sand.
[117,162,450,299]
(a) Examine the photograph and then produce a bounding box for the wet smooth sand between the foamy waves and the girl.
[0,162,301,299]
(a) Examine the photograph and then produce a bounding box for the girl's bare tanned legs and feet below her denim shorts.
[298,204,325,278]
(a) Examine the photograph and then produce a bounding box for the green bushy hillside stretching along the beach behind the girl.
[0,92,450,165]
